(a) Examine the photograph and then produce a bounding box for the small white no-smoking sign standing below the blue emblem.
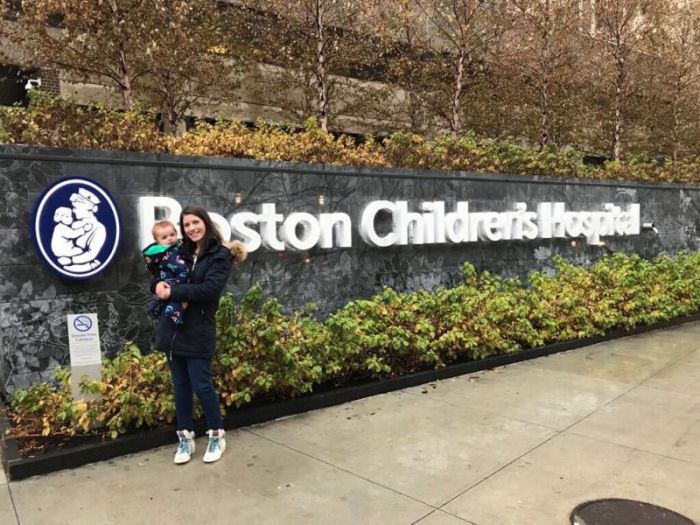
[67,314,102,399]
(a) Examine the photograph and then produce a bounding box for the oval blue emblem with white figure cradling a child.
[32,177,121,279]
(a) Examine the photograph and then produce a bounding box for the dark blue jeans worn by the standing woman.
[168,355,223,430]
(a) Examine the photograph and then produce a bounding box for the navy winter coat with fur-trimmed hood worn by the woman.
[151,239,233,359]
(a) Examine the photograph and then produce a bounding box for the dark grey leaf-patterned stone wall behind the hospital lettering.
[0,146,700,392]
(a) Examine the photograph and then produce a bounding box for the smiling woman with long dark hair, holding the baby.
[152,206,232,464]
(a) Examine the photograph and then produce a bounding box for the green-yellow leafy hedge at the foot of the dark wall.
[9,253,700,454]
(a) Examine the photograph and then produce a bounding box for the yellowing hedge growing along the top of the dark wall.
[0,90,700,183]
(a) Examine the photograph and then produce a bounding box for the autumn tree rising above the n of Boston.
[242,0,382,131]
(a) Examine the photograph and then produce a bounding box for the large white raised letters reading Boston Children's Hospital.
[139,196,641,251]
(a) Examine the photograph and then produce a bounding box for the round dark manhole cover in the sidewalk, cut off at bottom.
[571,499,696,525]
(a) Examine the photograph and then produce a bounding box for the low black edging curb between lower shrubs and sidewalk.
[0,312,700,481]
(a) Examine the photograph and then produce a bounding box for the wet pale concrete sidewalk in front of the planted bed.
[0,323,700,525]
